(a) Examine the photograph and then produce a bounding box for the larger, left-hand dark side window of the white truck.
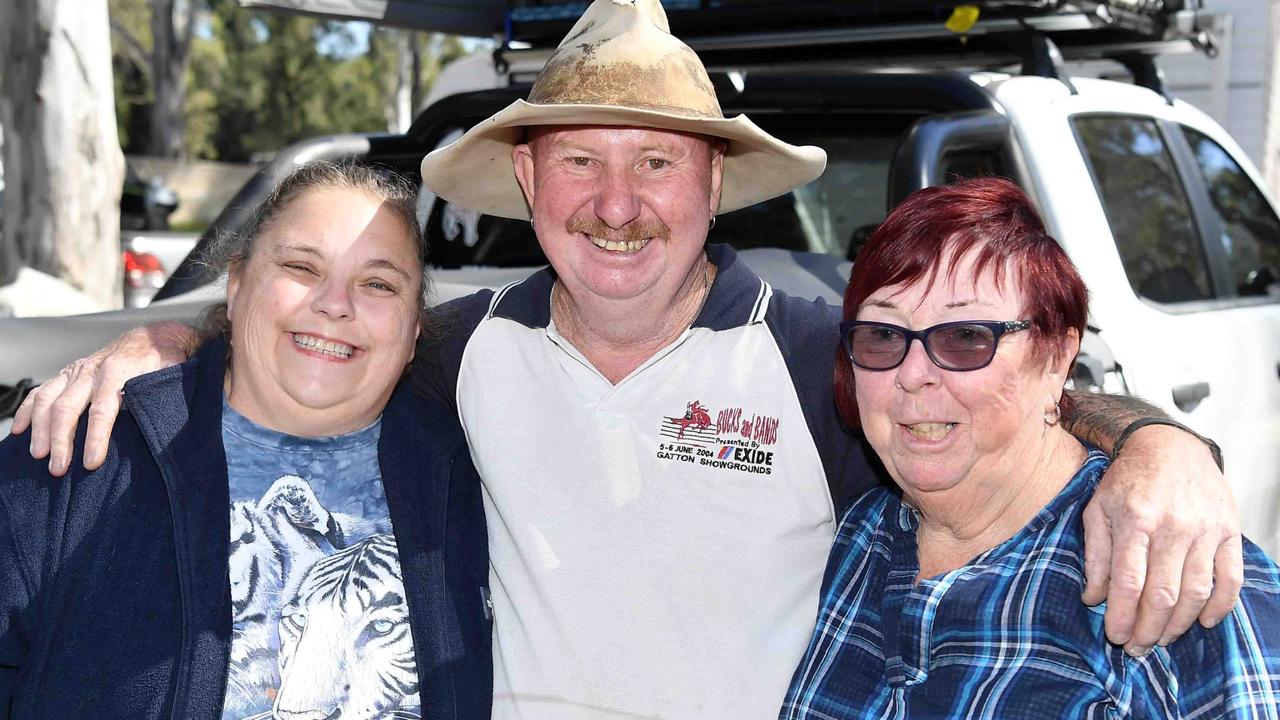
[1073,115,1213,302]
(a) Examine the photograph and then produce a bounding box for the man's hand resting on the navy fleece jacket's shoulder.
[10,323,200,477]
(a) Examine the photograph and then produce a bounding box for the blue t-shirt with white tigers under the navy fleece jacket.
[223,404,421,720]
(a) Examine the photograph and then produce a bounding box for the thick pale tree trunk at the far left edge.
[0,0,124,306]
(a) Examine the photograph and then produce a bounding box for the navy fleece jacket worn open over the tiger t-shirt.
[0,341,493,720]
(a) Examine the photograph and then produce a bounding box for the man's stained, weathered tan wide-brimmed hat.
[422,0,827,220]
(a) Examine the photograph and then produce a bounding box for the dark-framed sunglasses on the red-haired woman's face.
[840,320,1032,372]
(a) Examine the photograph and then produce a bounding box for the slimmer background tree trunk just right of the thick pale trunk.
[150,0,196,158]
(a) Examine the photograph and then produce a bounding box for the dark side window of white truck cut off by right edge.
[1183,127,1280,296]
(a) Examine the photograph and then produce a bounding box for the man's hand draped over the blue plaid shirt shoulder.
[1084,425,1244,656]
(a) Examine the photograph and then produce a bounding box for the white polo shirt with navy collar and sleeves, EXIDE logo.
[419,246,874,720]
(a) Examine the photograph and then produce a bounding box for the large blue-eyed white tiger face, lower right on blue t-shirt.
[273,534,421,720]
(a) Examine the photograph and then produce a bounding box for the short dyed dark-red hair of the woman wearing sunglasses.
[835,178,1089,428]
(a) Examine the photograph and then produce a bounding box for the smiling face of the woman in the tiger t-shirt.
[227,187,422,436]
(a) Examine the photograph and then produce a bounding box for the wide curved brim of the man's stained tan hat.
[422,100,827,220]
